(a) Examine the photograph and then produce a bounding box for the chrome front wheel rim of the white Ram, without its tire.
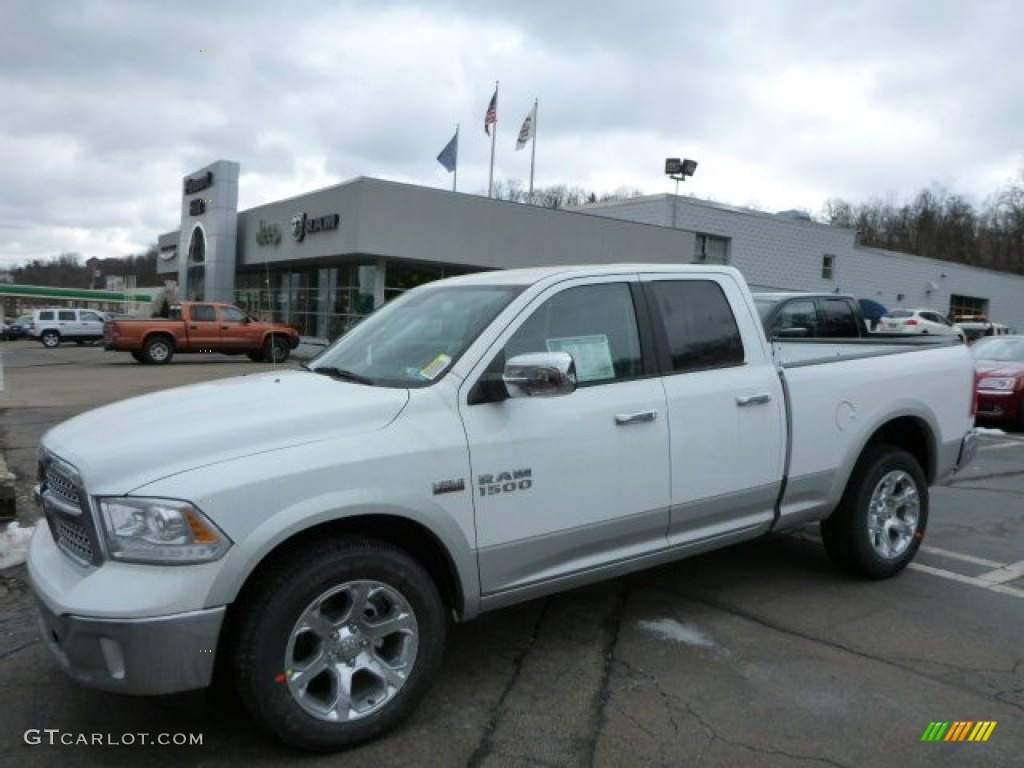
[285,581,420,722]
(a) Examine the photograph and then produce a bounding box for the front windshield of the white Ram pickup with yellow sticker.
[309,286,522,387]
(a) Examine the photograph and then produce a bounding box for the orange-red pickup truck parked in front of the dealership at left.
[103,301,299,365]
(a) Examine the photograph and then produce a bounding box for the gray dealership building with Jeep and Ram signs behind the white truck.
[158,161,1024,339]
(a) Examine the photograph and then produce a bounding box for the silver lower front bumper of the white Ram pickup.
[37,599,224,695]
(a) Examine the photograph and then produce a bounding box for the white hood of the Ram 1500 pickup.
[42,371,409,495]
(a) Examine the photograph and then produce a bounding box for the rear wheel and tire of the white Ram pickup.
[821,445,928,579]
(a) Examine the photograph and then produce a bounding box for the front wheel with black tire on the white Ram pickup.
[227,538,446,752]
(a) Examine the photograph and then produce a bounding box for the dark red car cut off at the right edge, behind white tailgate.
[971,336,1024,430]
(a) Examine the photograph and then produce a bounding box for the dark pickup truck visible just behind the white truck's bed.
[754,293,871,339]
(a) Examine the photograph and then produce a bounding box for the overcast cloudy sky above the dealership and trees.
[0,0,1024,267]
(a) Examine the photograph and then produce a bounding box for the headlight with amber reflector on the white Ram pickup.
[96,497,231,565]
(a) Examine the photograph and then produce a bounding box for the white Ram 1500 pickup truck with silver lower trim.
[29,265,976,751]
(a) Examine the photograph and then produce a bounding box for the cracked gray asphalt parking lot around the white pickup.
[0,342,1024,768]
